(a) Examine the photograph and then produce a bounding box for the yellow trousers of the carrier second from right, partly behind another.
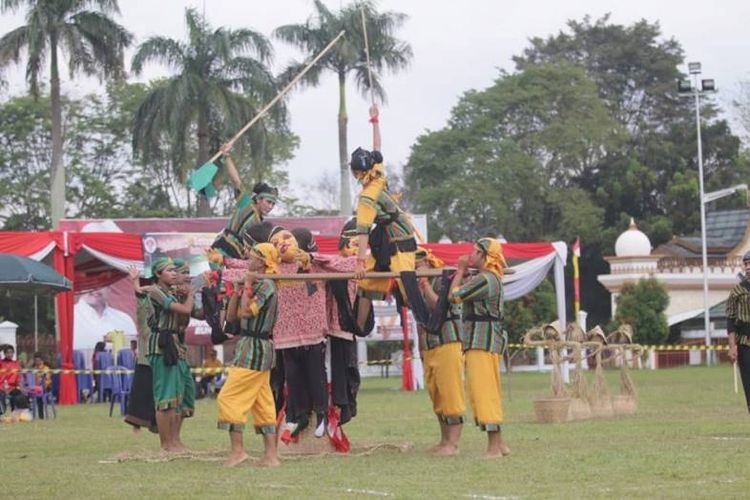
[424,342,466,425]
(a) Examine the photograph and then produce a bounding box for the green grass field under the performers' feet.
[0,365,750,499]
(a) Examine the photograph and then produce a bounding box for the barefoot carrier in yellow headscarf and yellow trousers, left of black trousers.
[217,243,280,467]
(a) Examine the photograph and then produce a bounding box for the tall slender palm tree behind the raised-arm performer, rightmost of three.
[274,0,412,214]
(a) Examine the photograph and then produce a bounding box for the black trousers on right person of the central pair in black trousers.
[329,337,360,425]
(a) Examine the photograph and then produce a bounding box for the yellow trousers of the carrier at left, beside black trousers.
[216,366,276,434]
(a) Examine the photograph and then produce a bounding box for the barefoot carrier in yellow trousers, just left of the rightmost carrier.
[417,247,466,456]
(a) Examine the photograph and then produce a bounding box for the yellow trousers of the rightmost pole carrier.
[464,349,503,431]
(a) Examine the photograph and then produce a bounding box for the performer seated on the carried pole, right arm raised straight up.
[350,104,417,332]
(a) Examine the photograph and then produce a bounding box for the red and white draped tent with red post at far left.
[0,231,143,404]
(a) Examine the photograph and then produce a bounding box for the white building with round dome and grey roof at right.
[598,210,750,341]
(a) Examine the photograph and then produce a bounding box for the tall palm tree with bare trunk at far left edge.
[0,0,133,227]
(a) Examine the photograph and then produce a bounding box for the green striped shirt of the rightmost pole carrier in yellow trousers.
[451,271,508,354]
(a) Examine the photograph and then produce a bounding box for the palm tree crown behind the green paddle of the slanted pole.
[132,8,285,216]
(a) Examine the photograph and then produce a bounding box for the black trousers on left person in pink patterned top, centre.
[281,342,328,424]
